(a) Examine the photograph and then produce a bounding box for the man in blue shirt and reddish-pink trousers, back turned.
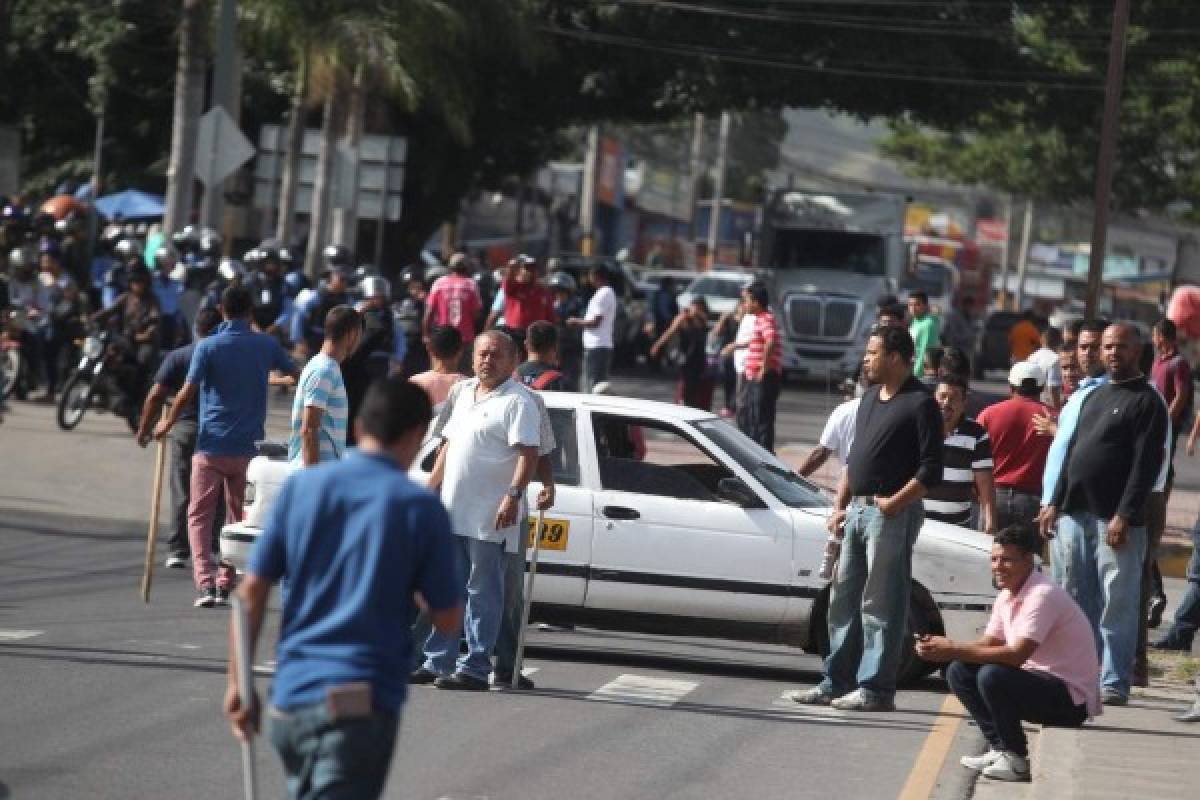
[154,287,296,608]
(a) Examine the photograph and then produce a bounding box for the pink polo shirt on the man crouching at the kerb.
[986,572,1102,717]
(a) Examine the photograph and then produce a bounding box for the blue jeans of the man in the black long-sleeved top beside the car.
[821,503,925,698]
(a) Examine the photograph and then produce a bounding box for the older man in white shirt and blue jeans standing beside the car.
[413,331,541,691]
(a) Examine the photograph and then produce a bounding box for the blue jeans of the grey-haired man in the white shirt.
[425,536,504,680]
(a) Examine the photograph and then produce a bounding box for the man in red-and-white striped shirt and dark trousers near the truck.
[738,281,784,452]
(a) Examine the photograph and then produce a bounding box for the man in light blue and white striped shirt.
[288,306,362,467]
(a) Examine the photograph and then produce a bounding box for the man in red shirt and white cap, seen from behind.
[977,361,1054,528]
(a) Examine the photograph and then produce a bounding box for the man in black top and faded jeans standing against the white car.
[790,327,942,711]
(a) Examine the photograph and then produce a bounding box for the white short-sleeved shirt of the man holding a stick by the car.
[442,378,541,553]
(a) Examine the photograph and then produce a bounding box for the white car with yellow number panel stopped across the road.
[221,392,995,680]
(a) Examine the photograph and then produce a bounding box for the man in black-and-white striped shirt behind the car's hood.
[924,374,996,535]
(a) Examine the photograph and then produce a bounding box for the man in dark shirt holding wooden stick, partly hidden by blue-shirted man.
[136,308,224,570]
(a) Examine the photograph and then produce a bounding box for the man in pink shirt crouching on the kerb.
[917,525,1102,781]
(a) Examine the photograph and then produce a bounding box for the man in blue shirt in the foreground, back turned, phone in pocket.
[224,378,463,798]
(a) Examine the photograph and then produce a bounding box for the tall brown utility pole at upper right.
[1084,0,1129,318]
